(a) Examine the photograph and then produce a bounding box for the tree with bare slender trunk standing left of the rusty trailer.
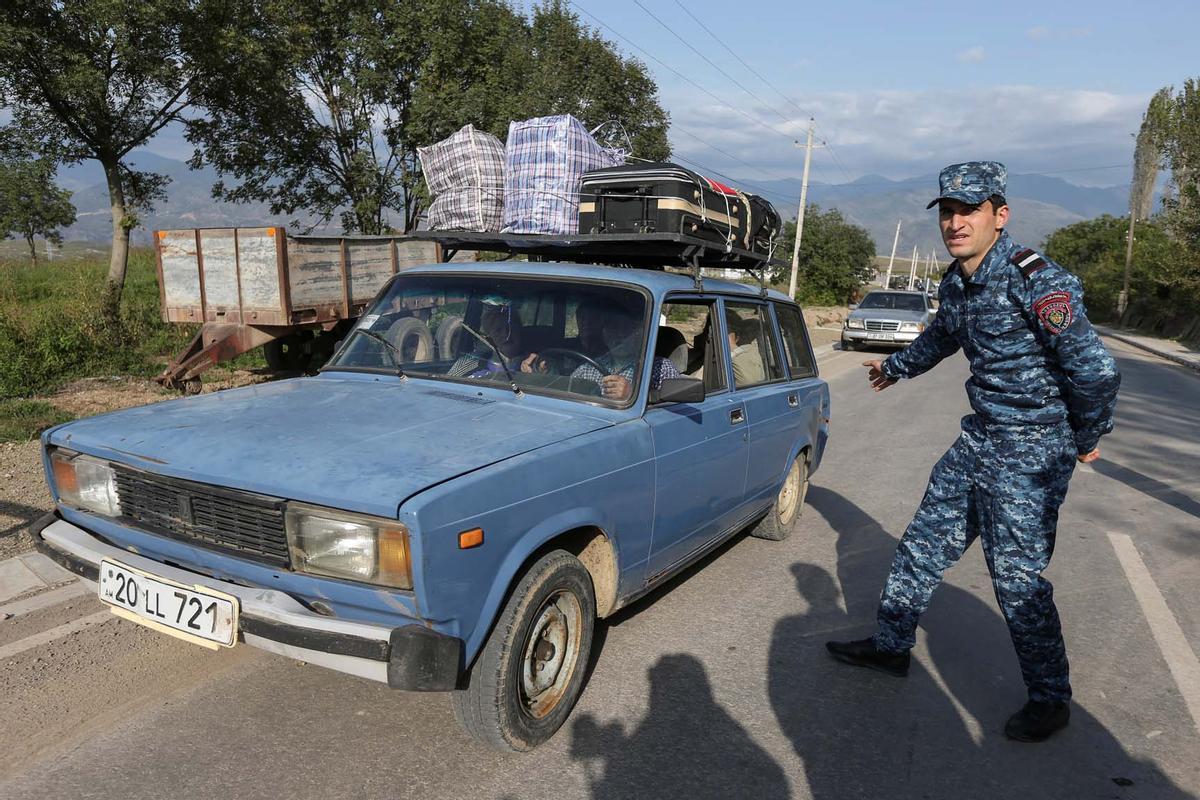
[0,0,220,324]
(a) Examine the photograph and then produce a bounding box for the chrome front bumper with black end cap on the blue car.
[31,512,463,692]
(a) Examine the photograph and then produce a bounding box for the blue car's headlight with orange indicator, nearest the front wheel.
[284,503,413,589]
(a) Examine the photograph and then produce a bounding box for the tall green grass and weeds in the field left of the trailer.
[0,252,196,398]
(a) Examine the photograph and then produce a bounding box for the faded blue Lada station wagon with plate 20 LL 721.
[35,263,829,751]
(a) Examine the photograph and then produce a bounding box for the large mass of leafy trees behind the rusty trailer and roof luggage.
[187,0,670,234]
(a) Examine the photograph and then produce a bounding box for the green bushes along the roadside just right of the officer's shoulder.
[1045,215,1184,319]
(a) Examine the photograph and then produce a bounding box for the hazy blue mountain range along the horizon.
[49,150,1129,258]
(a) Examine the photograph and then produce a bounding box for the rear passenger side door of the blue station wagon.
[724,297,799,510]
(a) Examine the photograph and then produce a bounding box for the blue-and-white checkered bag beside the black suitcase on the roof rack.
[504,114,625,234]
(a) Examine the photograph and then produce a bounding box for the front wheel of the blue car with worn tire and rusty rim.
[451,551,596,751]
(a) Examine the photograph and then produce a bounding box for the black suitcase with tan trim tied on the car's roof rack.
[580,163,753,248]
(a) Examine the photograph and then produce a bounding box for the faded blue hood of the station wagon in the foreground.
[48,373,611,517]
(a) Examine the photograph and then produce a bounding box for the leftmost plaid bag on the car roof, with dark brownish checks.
[416,125,504,231]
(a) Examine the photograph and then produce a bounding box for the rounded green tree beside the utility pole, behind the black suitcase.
[772,205,875,306]
